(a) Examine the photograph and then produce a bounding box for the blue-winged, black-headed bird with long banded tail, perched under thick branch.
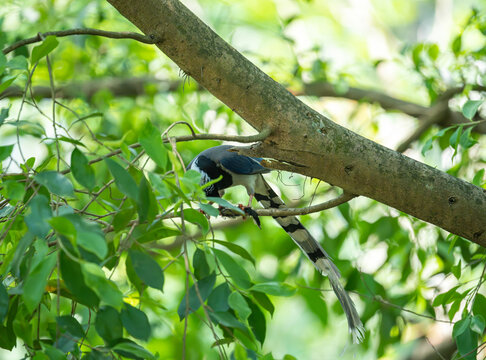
[187,145,365,343]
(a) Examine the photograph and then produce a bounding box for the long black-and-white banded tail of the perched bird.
[255,175,365,343]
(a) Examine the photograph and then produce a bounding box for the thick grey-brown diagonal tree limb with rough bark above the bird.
[108,0,486,246]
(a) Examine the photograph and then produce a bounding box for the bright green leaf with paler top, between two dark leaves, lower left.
[81,263,123,308]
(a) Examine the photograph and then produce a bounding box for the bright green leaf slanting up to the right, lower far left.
[22,253,57,312]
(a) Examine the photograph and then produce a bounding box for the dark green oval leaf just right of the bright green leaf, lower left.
[128,249,164,291]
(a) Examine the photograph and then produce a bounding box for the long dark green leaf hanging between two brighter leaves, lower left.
[59,252,100,307]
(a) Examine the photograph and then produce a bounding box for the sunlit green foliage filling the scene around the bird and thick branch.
[0,0,486,360]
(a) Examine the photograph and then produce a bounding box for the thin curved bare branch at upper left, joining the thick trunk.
[2,28,158,55]
